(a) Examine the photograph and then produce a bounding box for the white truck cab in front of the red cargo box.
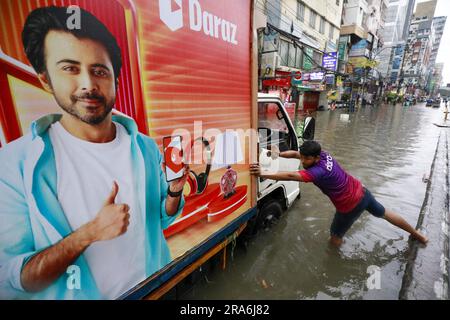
[255,93,300,229]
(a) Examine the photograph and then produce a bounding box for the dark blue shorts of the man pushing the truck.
[330,188,385,238]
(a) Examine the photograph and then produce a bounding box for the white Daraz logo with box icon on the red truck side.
[159,0,238,45]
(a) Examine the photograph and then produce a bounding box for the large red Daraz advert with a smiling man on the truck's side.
[0,0,253,299]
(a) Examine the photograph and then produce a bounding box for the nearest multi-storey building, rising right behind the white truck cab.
[255,0,343,109]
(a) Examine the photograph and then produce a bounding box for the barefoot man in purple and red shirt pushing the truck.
[250,141,428,247]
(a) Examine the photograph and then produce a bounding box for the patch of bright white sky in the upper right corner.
[416,0,450,85]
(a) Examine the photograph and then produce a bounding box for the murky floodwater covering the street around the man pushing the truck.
[182,103,443,300]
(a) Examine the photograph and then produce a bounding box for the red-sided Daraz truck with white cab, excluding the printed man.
[0,0,306,299]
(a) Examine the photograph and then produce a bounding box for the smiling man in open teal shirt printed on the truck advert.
[0,7,189,299]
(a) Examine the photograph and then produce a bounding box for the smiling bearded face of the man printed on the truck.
[39,31,116,125]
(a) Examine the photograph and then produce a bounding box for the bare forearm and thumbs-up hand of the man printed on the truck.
[20,182,130,292]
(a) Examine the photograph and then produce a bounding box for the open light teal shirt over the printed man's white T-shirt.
[0,114,184,299]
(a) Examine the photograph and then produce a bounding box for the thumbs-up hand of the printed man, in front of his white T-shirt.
[84,181,130,242]
